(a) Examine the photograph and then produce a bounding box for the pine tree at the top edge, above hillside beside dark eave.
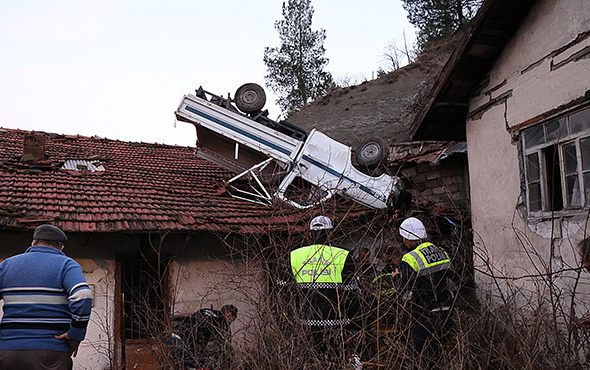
[402,0,483,50]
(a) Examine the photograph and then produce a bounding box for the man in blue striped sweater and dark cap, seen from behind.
[0,225,92,370]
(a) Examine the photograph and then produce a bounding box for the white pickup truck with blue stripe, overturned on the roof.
[175,84,403,208]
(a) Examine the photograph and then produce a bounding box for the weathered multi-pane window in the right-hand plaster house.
[522,107,590,214]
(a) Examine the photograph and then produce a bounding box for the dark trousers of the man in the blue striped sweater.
[0,349,73,370]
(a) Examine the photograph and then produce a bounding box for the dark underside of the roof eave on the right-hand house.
[410,0,537,141]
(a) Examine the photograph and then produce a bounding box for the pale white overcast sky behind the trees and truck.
[0,0,415,146]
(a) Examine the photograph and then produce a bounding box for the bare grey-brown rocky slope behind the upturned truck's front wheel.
[287,35,459,148]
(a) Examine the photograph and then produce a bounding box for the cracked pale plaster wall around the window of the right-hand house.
[467,0,590,302]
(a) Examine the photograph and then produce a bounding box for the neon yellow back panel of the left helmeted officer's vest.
[291,244,348,288]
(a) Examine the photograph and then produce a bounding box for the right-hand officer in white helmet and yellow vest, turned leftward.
[392,217,453,369]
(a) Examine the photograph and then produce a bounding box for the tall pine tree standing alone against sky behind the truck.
[264,0,332,116]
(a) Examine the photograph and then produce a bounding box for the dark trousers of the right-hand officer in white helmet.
[411,310,454,369]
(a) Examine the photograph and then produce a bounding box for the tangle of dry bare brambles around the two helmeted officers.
[118,204,590,370]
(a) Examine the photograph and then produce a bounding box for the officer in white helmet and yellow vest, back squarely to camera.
[290,216,359,359]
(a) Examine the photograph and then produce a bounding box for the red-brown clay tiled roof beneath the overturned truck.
[0,129,300,233]
